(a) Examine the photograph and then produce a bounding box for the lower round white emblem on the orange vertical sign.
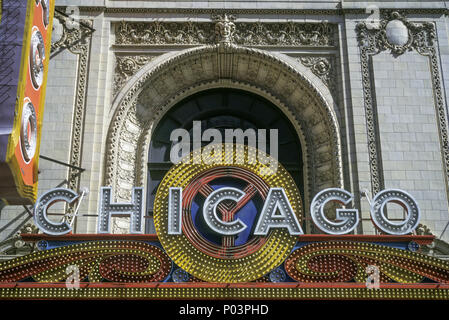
[20,98,37,163]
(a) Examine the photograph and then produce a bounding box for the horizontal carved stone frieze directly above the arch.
[115,18,337,47]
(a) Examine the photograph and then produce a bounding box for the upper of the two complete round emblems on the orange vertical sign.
[30,27,45,90]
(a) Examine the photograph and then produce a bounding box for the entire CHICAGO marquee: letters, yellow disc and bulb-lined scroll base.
[0,147,449,299]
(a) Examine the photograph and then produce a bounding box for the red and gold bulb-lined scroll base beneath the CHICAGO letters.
[0,234,449,300]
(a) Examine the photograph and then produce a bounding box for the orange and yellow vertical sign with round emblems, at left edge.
[0,0,54,204]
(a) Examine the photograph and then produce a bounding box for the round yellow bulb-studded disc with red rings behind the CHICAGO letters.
[154,146,302,283]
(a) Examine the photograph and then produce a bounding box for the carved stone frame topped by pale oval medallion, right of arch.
[356,11,449,194]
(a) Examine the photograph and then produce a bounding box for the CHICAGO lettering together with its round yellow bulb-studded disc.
[34,148,420,283]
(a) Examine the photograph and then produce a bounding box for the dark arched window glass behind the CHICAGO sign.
[145,88,304,233]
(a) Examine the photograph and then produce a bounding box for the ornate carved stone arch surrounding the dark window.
[103,43,343,232]
